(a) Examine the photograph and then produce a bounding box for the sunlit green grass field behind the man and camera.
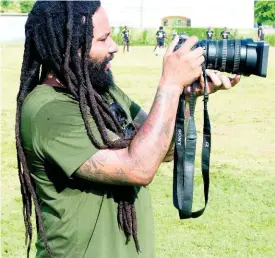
[1,44,275,258]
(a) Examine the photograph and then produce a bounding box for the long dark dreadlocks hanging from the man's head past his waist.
[15,1,140,257]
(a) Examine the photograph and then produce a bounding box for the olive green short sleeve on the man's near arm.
[35,101,116,177]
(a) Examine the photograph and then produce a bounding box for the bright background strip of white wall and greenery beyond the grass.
[0,0,275,45]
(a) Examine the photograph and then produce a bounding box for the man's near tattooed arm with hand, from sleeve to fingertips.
[75,37,204,185]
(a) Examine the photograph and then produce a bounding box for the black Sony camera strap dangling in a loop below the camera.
[173,69,211,219]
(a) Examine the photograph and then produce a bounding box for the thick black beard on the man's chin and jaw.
[88,58,115,94]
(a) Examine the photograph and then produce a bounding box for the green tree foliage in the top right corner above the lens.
[254,0,275,25]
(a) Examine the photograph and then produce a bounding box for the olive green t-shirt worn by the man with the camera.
[21,85,155,258]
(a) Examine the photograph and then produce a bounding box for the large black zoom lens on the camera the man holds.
[174,35,269,77]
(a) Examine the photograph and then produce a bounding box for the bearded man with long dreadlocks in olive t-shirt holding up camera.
[16,1,242,258]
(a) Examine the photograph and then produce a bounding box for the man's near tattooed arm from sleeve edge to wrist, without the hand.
[75,87,183,185]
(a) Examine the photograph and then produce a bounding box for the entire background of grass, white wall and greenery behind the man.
[0,0,275,258]
